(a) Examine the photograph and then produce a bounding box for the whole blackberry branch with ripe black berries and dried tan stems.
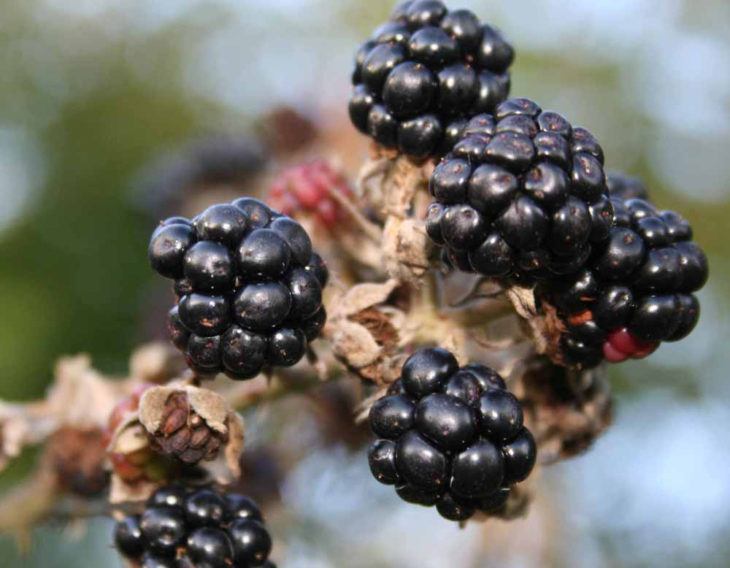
[0,0,708,568]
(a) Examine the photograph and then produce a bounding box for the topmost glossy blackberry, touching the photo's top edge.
[350,0,514,158]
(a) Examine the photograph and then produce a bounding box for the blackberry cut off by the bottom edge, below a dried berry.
[114,485,275,568]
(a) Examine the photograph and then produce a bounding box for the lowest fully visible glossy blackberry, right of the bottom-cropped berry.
[369,348,537,521]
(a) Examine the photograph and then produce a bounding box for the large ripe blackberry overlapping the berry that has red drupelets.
[426,99,613,279]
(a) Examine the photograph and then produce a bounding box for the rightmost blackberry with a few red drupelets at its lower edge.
[539,176,708,367]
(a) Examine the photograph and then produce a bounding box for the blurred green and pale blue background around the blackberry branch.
[0,0,730,568]
